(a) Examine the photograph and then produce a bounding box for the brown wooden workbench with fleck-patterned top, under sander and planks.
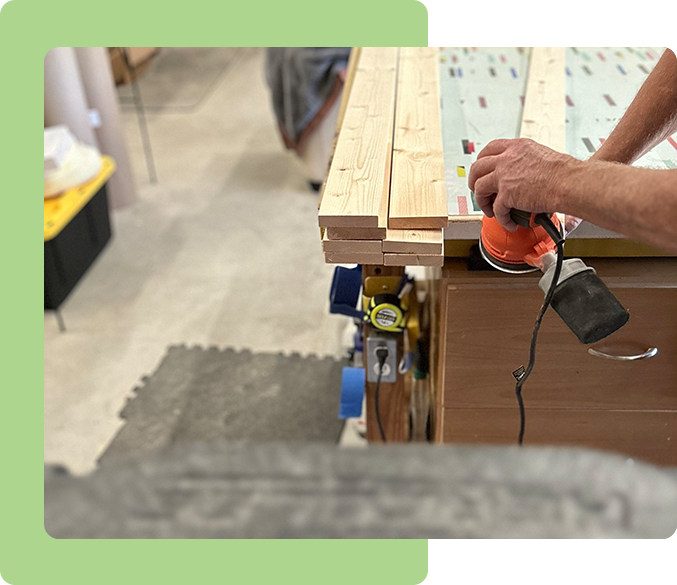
[320,48,677,465]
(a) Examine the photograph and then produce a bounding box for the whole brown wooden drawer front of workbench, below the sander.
[437,259,677,465]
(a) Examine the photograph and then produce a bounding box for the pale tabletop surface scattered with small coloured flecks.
[440,47,677,217]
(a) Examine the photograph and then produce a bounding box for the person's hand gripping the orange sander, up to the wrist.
[468,138,581,232]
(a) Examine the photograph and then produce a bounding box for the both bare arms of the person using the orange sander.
[468,49,677,251]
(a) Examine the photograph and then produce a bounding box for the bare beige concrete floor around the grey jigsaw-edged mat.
[45,49,346,473]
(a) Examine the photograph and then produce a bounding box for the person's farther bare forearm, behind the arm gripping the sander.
[590,49,677,164]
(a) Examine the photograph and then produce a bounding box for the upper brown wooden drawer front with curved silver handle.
[444,286,677,411]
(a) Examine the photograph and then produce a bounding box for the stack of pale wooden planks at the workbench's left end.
[319,47,447,266]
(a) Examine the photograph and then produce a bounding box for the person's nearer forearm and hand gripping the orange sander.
[468,138,677,252]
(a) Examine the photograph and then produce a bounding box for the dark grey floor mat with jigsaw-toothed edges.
[100,346,346,464]
